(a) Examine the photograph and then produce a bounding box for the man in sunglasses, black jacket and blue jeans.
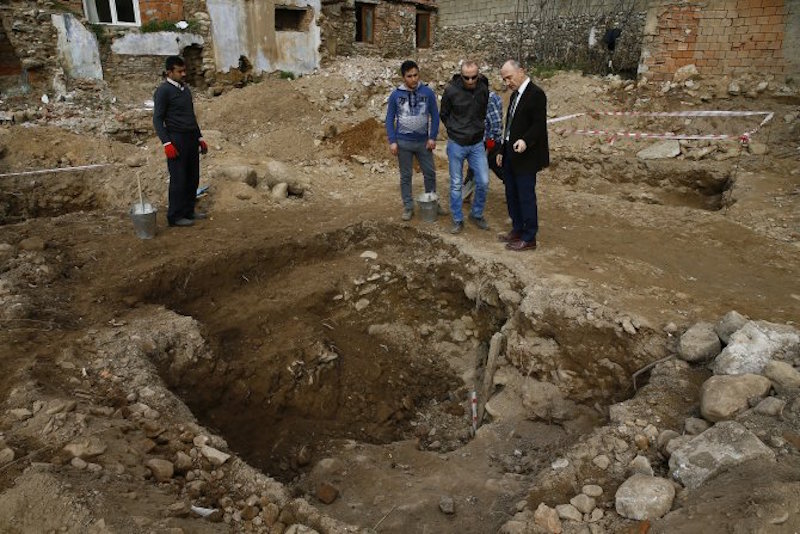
[439,61,489,234]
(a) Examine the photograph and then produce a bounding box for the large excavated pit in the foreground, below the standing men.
[131,224,663,532]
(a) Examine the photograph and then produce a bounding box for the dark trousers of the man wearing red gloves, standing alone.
[167,132,200,224]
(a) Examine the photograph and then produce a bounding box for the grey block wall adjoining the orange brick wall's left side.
[436,0,646,76]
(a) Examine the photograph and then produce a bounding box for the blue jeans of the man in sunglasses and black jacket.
[447,140,489,222]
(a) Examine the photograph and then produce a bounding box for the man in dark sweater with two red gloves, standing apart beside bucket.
[153,56,208,226]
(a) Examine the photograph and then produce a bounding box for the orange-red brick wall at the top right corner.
[639,0,800,81]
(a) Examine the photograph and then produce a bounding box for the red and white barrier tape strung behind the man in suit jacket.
[547,110,774,144]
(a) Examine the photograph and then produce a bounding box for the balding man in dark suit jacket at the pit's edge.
[497,59,550,251]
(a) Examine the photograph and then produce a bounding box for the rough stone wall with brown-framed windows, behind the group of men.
[320,0,438,58]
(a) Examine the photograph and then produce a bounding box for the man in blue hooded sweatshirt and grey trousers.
[386,60,446,221]
